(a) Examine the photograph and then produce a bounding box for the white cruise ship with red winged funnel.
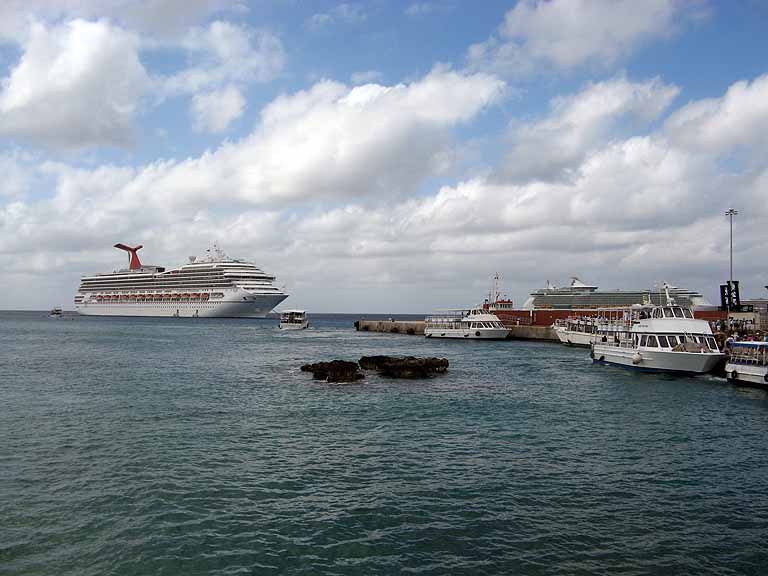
[75,244,288,318]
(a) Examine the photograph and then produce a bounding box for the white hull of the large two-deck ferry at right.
[592,344,725,374]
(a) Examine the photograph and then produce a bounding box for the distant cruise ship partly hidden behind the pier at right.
[523,277,714,310]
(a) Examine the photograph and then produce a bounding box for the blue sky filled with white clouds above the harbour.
[0,0,768,313]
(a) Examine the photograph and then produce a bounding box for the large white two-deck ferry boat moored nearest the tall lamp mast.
[590,299,725,374]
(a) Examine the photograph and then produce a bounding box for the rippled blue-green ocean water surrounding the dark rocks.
[0,312,768,576]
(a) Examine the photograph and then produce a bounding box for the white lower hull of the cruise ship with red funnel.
[75,291,288,318]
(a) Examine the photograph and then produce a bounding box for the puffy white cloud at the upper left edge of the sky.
[0,20,148,148]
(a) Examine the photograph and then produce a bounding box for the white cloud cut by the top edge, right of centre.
[468,0,700,76]
